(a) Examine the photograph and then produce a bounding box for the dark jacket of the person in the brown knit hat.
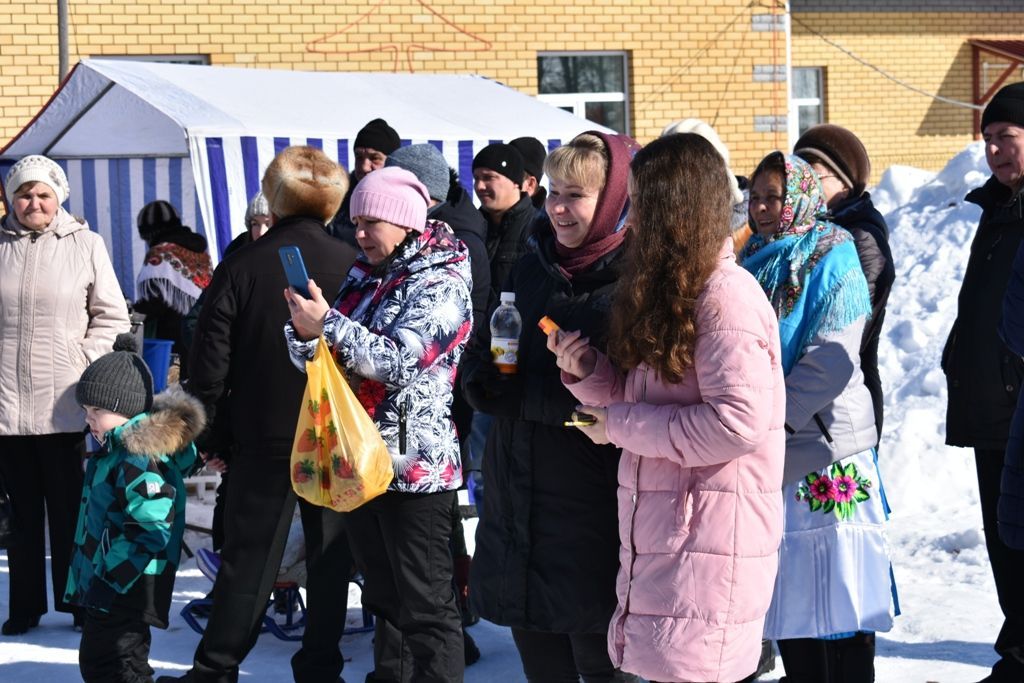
[833,193,896,439]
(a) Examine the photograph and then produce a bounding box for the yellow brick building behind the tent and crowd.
[0,0,1024,177]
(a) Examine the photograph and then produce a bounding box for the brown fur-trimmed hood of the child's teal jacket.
[118,384,206,458]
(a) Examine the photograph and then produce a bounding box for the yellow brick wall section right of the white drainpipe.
[793,9,1024,181]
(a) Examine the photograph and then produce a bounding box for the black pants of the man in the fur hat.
[191,452,351,683]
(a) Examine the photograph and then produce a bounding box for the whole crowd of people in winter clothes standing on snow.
[0,83,1024,683]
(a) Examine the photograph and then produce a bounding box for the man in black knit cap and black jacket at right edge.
[942,83,1024,682]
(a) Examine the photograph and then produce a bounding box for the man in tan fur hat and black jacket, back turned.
[162,146,355,683]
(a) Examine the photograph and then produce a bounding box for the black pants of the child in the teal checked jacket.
[78,610,153,683]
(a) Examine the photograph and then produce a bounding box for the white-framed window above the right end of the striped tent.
[537,52,630,133]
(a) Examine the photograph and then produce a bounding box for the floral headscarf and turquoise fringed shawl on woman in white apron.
[739,155,871,374]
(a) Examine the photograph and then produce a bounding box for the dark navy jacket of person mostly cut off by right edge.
[998,236,1024,550]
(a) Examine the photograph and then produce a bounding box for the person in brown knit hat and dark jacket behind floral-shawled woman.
[794,124,896,439]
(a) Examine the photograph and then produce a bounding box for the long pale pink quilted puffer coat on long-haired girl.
[562,239,785,681]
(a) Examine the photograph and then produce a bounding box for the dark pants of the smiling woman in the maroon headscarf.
[512,629,639,683]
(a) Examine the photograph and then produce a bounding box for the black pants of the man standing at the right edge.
[975,450,1024,683]
